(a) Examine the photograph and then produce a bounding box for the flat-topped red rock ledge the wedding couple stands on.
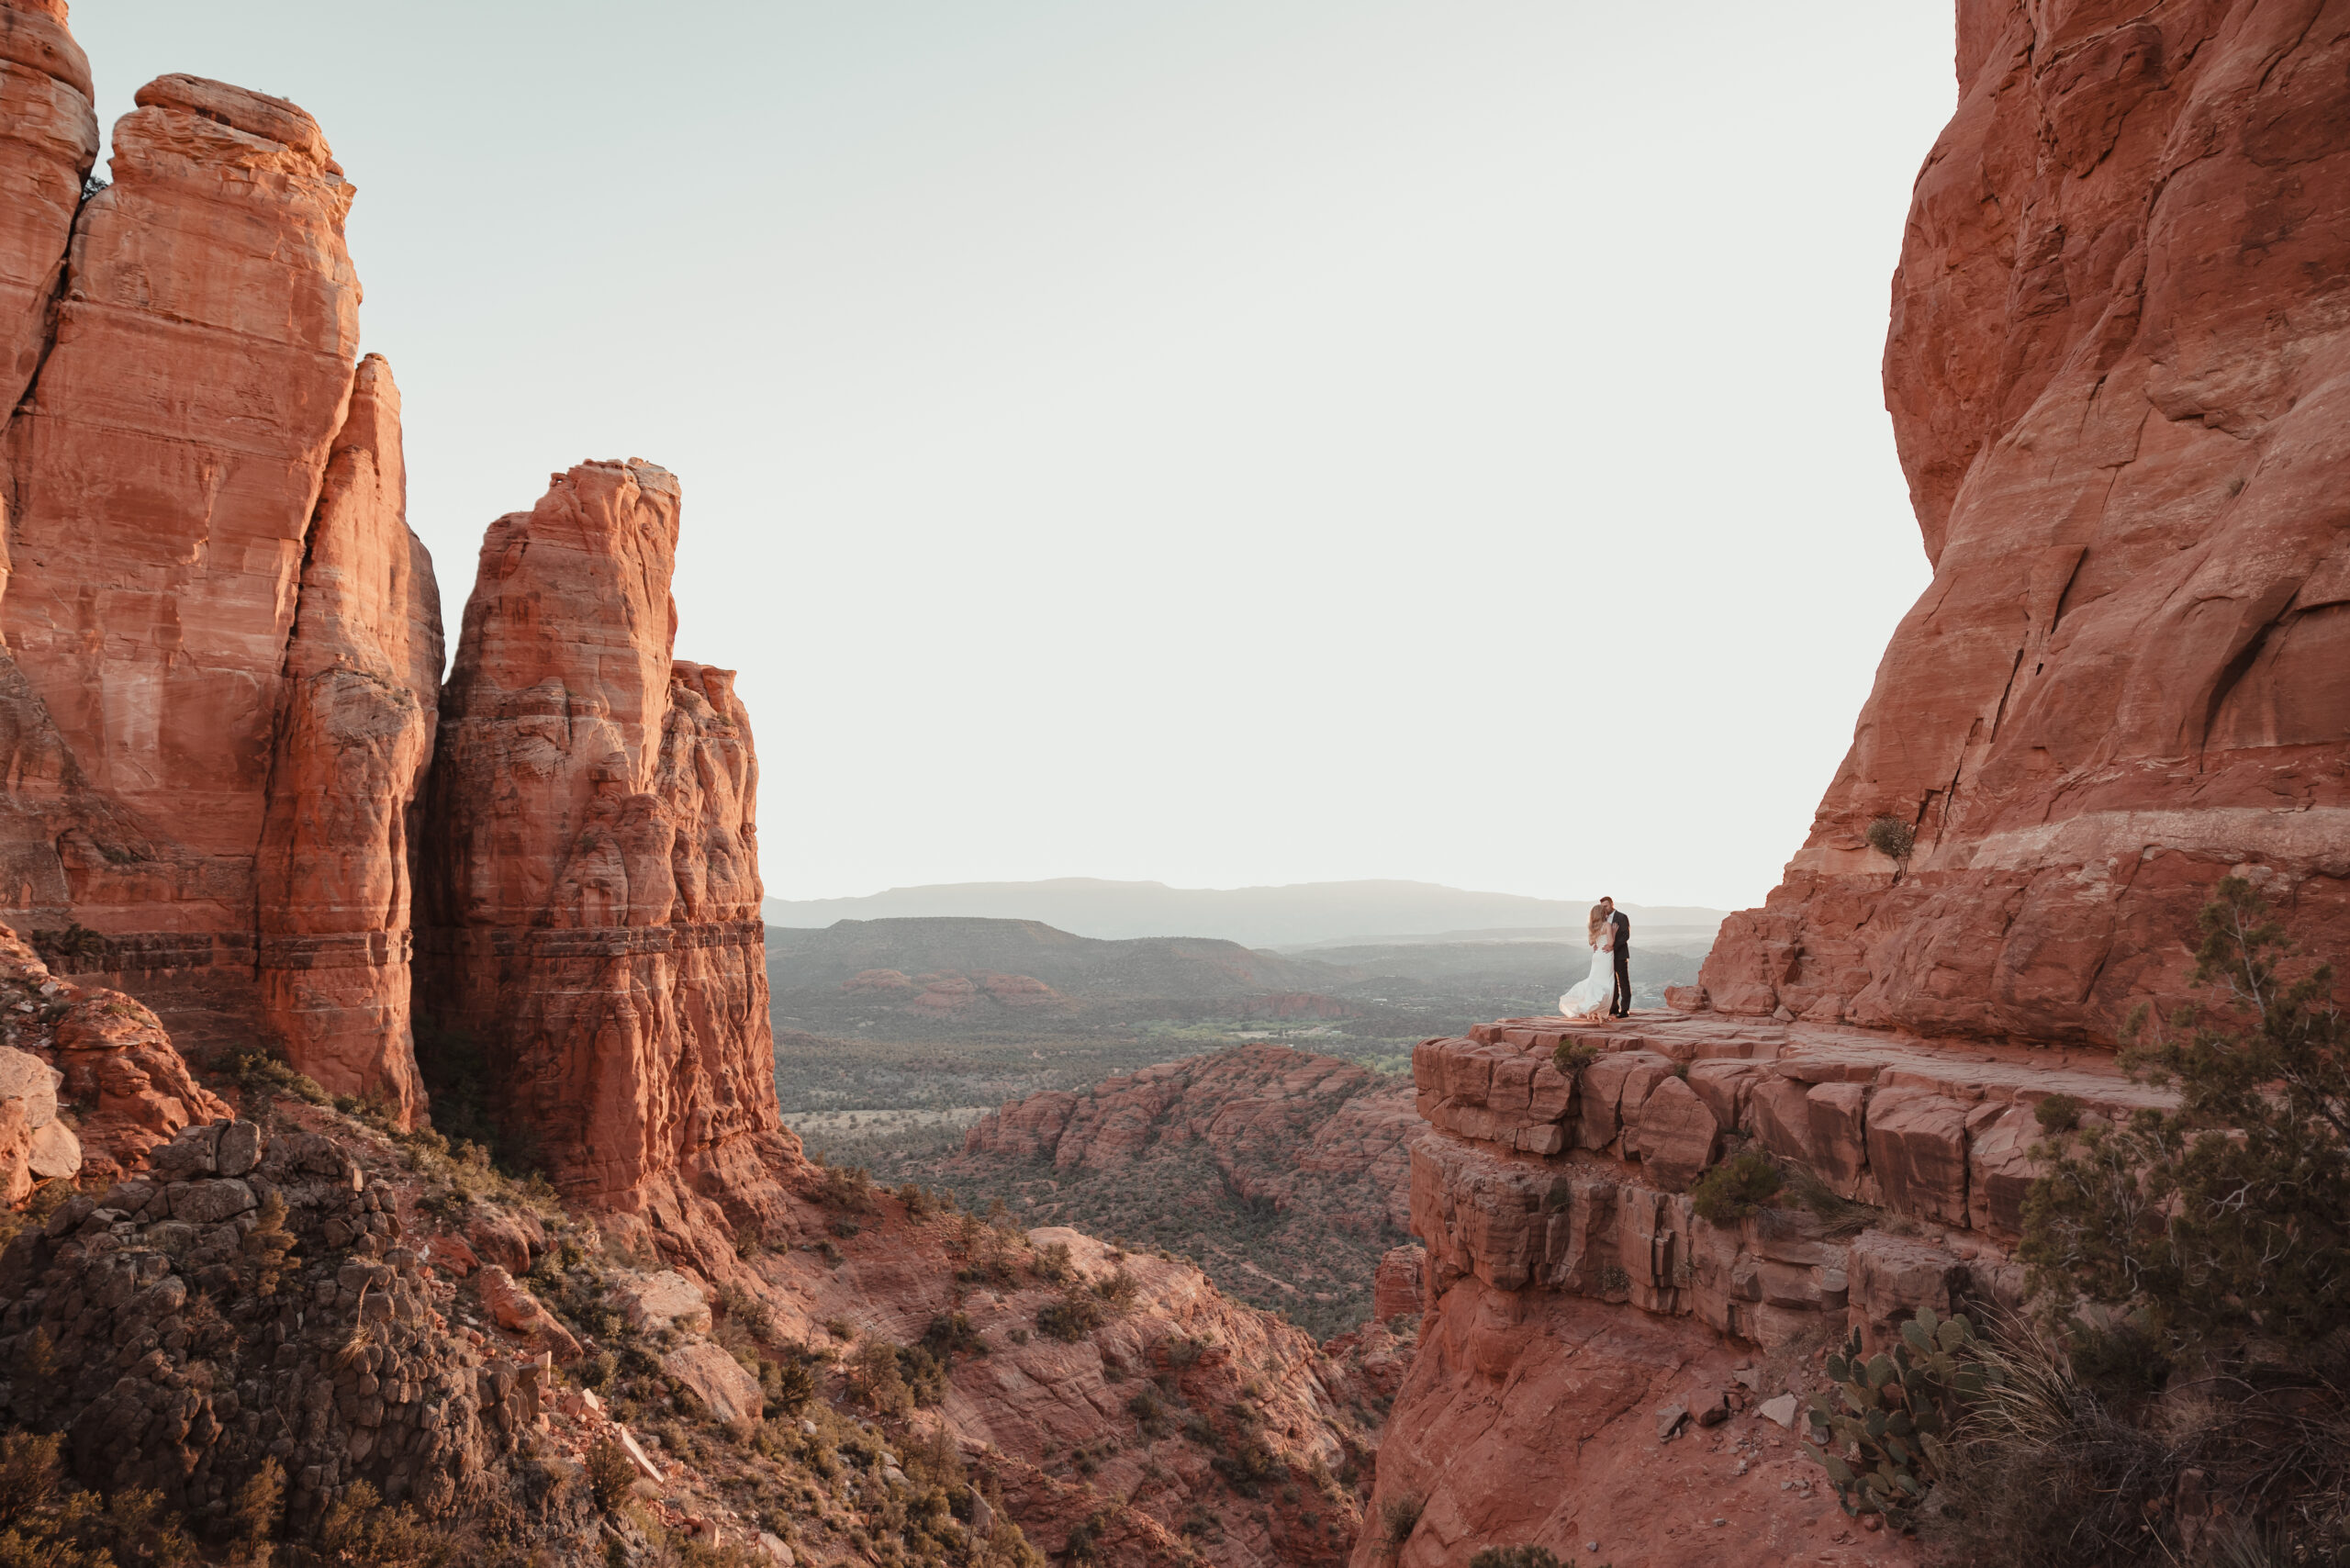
[1354,1014,2162,1568]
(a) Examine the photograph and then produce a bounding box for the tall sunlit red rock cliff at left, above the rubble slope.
[0,42,440,1116]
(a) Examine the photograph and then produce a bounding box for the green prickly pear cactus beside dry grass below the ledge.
[1803,1307,1988,1528]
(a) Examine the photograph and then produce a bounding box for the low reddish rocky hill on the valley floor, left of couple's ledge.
[928,1044,1419,1335]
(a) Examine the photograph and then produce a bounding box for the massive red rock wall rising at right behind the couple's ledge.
[1704,0,2350,1041]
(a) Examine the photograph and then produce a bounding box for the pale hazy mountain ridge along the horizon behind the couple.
[764,877,1728,947]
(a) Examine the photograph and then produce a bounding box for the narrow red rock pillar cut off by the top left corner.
[0,0,99,409]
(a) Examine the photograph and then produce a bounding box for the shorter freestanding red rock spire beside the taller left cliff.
[420,461,797,1271]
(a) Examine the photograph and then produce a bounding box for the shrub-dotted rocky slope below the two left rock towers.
[0,963,1407,1568]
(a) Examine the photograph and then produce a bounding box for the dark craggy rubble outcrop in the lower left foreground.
[0,1121,578,1518]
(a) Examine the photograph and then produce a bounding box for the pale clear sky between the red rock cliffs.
[73,0,1955,907]
